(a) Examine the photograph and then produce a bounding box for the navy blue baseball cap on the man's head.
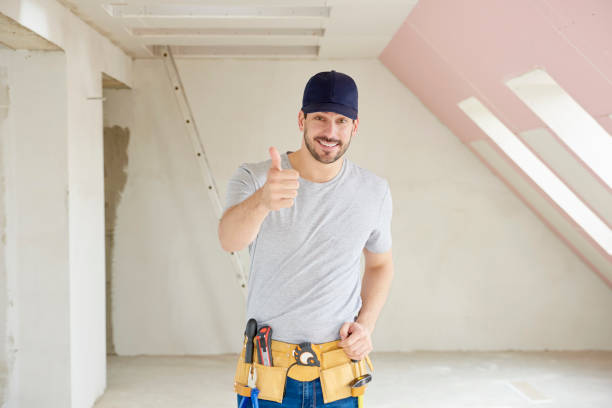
[302,70,357,119]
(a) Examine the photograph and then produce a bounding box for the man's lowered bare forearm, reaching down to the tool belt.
[357,262,393,333]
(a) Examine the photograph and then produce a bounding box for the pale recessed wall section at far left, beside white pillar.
[0,51,71,407]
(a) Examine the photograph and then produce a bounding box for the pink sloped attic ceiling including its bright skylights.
[380,0,612,288]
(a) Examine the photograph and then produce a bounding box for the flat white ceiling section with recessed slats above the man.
[60,0,418,59]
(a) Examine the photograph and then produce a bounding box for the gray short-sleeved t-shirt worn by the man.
[225,152,392,343]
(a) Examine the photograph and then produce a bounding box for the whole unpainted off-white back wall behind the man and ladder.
[110,60,612,354]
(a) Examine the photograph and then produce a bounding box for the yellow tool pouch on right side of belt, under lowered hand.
[321,349,366,404]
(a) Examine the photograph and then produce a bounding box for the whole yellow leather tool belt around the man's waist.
[234,338,374,404]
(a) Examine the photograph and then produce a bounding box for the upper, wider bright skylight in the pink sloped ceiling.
[506,69,612,187]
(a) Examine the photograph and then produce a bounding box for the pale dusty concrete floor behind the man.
[94,352,612,408]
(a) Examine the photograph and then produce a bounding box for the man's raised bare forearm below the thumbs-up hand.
[218,189,270,252]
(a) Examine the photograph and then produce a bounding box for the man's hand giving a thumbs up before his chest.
[262,147,300,211]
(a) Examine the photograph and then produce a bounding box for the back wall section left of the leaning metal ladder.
[109,60,244,355]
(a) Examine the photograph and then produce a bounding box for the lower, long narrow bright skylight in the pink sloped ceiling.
[458,97,612,254]
